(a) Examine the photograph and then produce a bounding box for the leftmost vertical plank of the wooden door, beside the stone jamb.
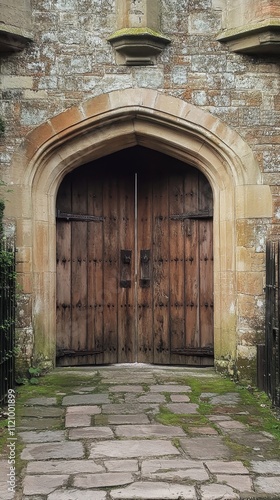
[56,178,72,366]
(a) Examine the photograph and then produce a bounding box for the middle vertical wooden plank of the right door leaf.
[169,174,186,364]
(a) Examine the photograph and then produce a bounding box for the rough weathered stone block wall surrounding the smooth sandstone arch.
[0,0,280,380]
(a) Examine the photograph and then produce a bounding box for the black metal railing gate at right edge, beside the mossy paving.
[257,241,280,407]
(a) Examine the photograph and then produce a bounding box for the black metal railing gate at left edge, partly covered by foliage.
[0,221,16,407]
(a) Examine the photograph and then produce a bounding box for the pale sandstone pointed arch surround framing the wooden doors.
[8,89,272,376]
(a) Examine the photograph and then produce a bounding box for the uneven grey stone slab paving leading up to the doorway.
[10,365,280,500]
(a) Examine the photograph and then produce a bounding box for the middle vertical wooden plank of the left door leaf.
[87,173,104,364]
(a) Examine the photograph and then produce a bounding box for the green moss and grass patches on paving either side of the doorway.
[0,368,280,457]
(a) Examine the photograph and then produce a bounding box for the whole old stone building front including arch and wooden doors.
[0,0,280,380]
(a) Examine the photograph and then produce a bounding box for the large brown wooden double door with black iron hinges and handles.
[57,147,213,366]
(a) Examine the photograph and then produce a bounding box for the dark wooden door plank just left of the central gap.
[117,174,135,363]
